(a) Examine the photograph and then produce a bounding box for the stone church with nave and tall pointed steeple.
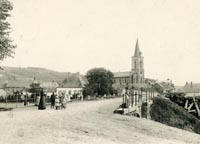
[113,39,147,90]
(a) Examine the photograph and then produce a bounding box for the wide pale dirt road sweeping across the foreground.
[0,98,200,144]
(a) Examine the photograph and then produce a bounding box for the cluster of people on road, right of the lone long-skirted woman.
[50,92,67,110]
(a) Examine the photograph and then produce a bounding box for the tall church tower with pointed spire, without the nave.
[131,39,144,84]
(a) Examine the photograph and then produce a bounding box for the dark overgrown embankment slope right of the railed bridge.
[150,97,200,134]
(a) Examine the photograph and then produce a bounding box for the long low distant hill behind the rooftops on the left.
[0,67,71,83]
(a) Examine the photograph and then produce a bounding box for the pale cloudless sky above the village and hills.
[1,0,200,85]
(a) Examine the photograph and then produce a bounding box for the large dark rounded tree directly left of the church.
[84,68,113,95]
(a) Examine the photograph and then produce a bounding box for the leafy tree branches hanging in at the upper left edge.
[0,0,16,61]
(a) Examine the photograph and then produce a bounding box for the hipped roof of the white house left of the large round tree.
[59,73,88,88]
